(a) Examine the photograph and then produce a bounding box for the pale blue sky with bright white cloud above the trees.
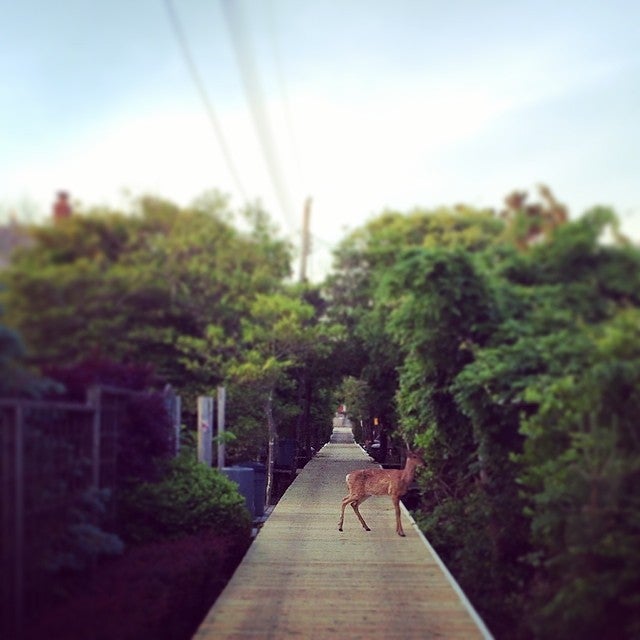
[0,0,640,277]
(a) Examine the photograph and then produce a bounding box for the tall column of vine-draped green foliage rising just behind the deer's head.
[382,250,495,493]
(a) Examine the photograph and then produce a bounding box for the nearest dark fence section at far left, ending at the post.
[0,401,94,635]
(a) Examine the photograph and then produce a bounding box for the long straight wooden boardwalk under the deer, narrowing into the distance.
[194,428,491,640]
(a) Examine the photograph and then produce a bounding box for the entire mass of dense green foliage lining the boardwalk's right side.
[344,199,640,638]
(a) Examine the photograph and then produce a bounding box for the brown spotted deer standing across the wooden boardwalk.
[338,451,424,538]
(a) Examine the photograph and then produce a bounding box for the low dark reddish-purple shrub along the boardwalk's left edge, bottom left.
[24,531,250,640]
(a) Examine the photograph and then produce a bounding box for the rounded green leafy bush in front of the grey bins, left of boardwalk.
[119,452,251,543]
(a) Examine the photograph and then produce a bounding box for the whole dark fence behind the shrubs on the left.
[0,386,176,638]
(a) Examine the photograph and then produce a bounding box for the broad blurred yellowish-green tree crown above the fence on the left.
[2,192,290,393]
